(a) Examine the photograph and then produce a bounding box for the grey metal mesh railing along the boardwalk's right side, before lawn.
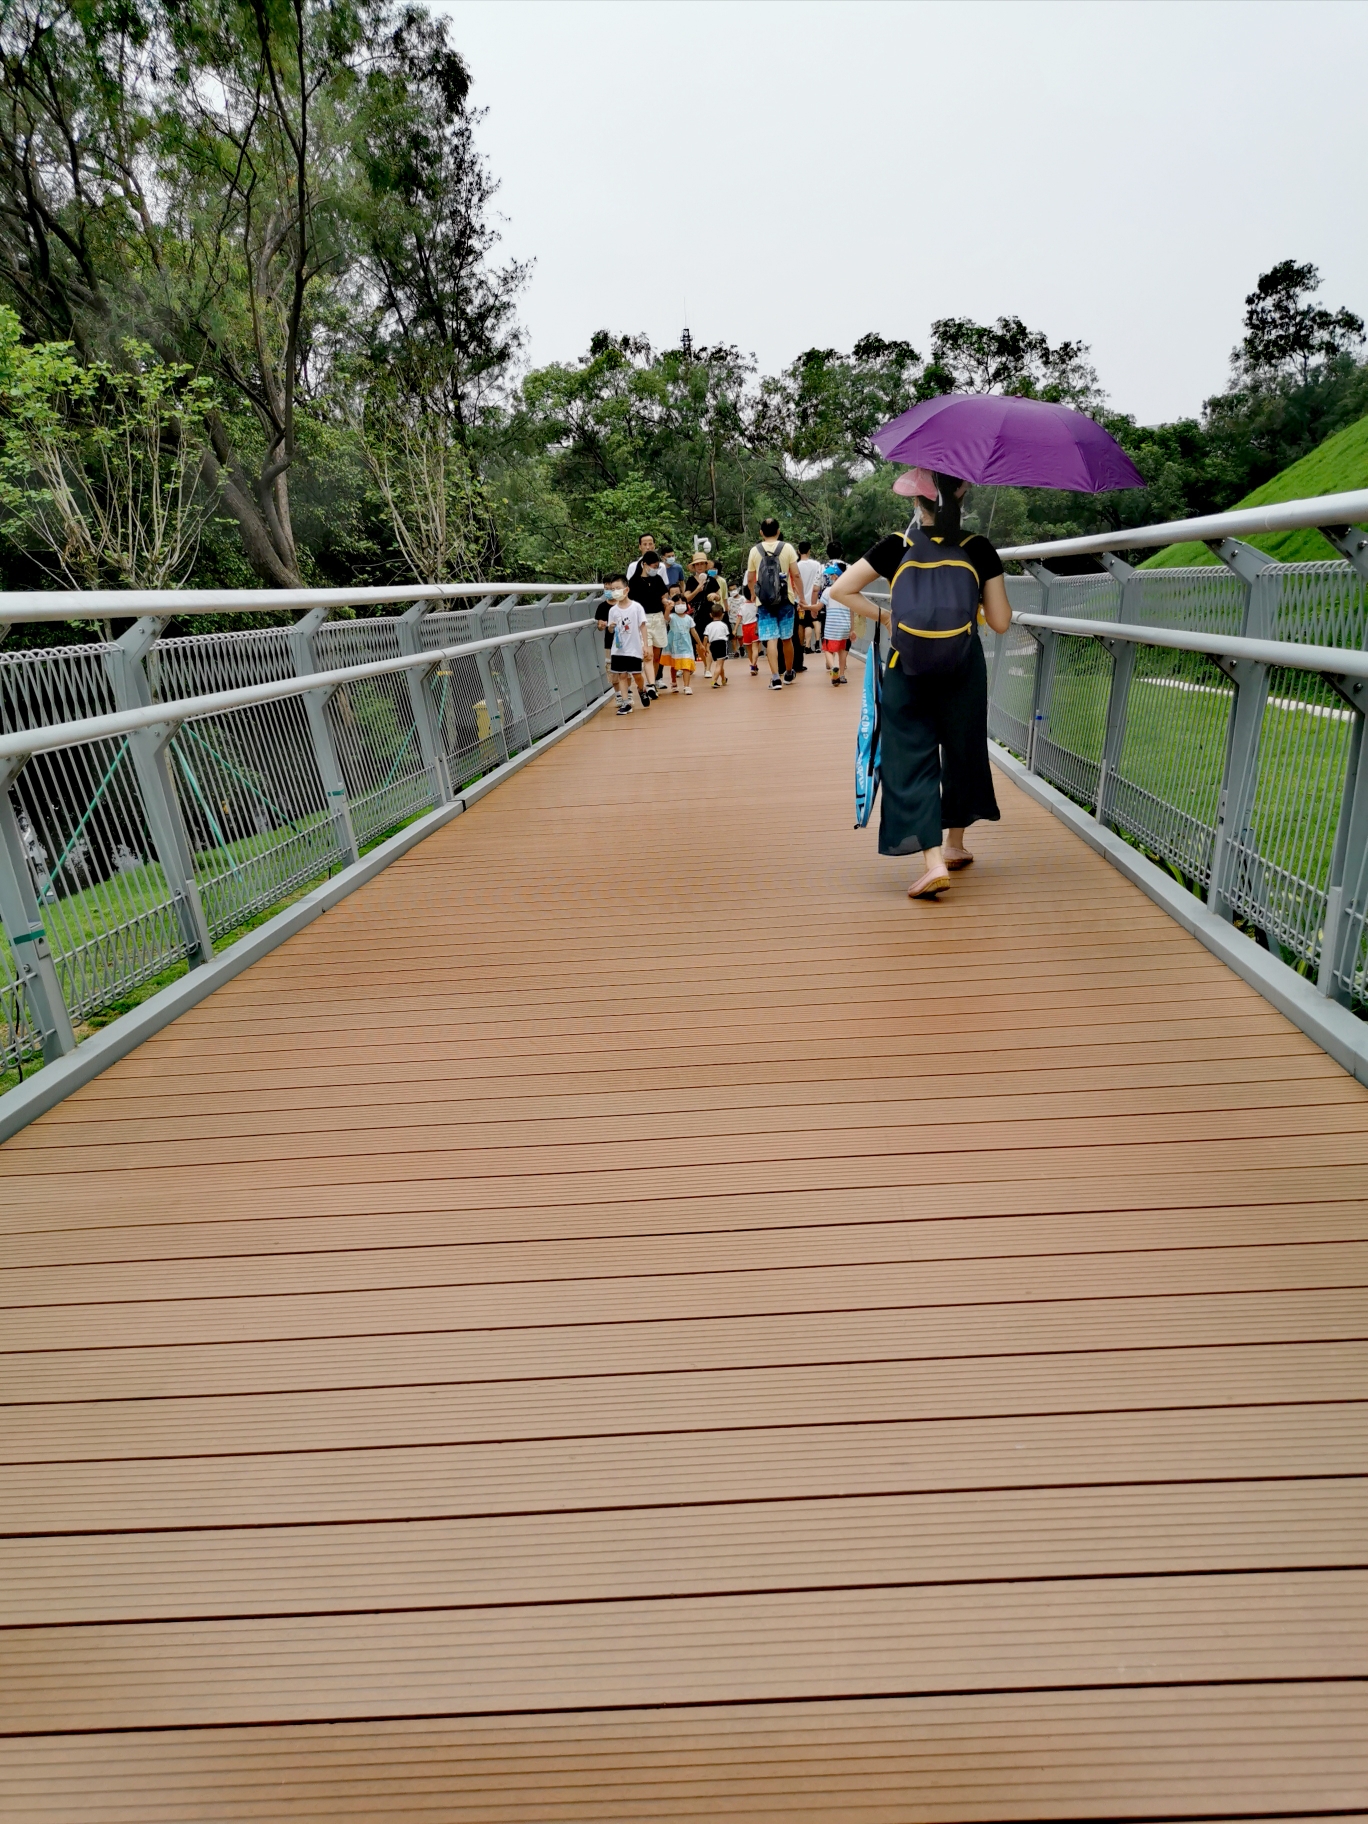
[983,492,1368,1009]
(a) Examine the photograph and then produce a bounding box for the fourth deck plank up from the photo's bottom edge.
[0,1401,1368,1534]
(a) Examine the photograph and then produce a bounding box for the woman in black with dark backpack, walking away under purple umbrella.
[830,469,1012,899]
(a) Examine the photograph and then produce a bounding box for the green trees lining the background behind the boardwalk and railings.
[0,0,1368,612]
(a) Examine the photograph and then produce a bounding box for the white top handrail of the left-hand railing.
[0,582,602,624]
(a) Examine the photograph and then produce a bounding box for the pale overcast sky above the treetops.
[435,0,1368,423]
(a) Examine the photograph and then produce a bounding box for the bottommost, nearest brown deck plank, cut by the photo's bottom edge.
[0,1684,1368,1824]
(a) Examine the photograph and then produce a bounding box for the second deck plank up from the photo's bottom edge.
[0,1570,1368,1733]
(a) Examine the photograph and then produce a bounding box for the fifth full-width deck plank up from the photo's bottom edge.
[0,1342,1368,1463]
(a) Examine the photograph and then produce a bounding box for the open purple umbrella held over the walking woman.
[874,392,1145,494]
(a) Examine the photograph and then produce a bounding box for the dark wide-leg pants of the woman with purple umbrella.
[879,635,1001,855]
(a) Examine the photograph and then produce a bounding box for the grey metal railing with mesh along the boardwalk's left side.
[0,584,606,1073]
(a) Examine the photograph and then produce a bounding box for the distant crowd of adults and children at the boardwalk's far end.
[598,520,852,715]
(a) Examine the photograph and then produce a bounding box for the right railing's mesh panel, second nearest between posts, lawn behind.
[1111,646,1235,885]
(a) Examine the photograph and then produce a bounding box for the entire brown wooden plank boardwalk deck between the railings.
[0,673,1368,1824]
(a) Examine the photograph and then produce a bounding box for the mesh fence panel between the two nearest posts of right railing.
[1226,671,1353,963]
